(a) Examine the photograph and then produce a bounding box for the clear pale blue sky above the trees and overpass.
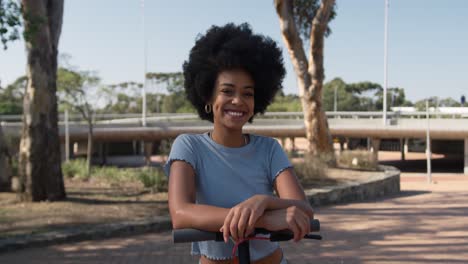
[0,0,468,101]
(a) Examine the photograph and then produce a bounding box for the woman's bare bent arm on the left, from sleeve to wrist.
[168,160,229,231]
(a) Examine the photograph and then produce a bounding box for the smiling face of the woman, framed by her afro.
[212,69,254,130]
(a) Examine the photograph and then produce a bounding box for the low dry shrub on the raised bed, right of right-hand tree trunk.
[337,150,379,170]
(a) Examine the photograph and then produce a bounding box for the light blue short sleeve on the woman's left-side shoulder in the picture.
[164,134,197,177]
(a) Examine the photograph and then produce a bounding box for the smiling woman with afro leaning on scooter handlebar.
[165,24,313,263]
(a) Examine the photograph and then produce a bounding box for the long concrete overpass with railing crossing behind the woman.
[2,112,468,175]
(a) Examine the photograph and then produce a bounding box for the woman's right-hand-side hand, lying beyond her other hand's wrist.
[262,206,312,242]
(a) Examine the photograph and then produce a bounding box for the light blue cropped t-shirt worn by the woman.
[164,133,292,261]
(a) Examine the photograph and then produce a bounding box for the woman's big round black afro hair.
[183,23,286,122]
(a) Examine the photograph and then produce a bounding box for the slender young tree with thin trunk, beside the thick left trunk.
[57,68,99,176]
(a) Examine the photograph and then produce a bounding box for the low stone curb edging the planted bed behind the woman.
[0,166,400,253]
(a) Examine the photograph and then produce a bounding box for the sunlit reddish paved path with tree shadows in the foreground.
[0,173,468,264]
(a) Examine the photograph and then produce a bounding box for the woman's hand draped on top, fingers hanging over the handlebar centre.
[220,195,270,242]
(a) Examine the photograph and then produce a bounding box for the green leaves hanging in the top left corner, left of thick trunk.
[0,0,21,49]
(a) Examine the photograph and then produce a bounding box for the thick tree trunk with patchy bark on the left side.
[19,0,66,201]
